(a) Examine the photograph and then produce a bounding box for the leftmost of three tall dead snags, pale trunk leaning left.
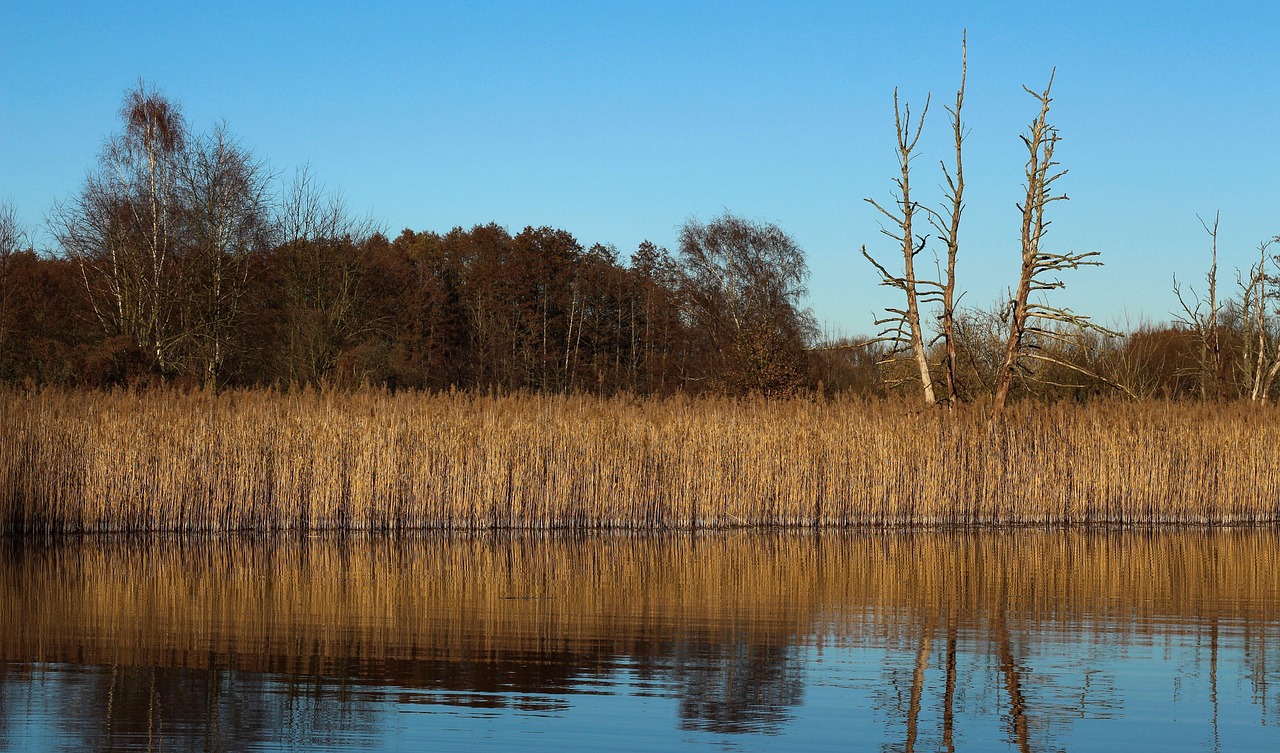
[863,88,938,405]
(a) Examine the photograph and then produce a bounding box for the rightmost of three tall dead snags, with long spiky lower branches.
[992,70,1115,416]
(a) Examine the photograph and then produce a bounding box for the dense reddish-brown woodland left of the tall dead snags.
[0,85,815,394]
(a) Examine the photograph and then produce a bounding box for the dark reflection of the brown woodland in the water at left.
[0,636,803,750]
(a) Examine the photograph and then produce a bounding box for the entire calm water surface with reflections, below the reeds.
[0,530,1280,752]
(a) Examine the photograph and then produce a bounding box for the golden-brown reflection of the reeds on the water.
[0,530,1280,672]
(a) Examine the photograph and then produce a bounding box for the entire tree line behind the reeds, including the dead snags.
[0,76,1280,406]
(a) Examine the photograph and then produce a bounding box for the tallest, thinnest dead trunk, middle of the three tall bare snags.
[929,33,969,410]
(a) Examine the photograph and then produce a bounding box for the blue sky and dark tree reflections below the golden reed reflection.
[0,621,1280,752]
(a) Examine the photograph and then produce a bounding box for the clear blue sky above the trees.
[0,0,1280,334]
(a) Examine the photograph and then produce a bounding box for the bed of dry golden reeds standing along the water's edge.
[0,391,1280,533]
